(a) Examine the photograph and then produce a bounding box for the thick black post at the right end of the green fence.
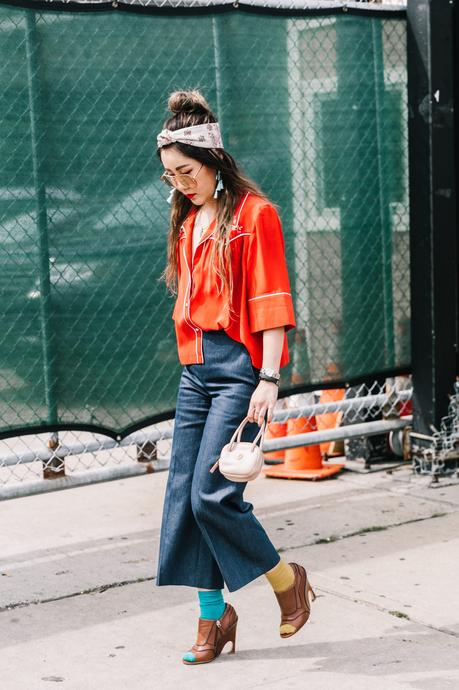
[407,0,457,434]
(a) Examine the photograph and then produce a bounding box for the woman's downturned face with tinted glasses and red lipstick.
[161,146,216,206]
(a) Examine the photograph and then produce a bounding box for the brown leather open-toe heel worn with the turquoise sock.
[182,604,238,666]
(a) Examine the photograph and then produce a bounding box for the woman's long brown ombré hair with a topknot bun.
[157,90,274,313]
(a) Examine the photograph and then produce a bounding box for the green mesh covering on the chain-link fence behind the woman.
[0,5,409,436]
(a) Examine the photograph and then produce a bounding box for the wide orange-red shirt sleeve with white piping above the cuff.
[246,204,296,333]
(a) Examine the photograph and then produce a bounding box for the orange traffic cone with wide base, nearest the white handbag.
[264,395,343,479]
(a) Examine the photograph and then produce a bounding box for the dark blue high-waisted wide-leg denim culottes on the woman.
[156,330,280,592]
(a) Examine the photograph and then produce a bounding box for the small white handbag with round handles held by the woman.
[210,417,266,482]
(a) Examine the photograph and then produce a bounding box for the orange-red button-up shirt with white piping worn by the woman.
[172,192,296,368]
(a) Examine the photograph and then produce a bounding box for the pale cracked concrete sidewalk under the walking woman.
[0,468,459,690]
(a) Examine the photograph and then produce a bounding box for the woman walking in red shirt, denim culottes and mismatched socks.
[156,91,314,664]
